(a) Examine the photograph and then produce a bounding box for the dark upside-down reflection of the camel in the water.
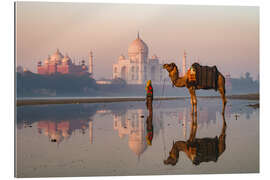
[164,113,227,166]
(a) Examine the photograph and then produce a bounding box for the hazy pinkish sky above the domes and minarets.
[16,2,259,79]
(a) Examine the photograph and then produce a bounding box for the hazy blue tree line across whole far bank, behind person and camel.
[16,70,259,97]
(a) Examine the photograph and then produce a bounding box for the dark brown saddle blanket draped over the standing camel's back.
[187,63,218,91]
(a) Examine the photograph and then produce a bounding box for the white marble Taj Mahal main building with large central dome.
[113,33,167,84]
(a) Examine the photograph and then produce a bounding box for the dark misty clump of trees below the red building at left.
[17,71,97,96]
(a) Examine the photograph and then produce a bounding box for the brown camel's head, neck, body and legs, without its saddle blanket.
[163,63,227,115]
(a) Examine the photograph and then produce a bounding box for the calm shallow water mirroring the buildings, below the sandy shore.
[16,98,259,177]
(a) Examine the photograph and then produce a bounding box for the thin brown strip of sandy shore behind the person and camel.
[17,94,259,106]
